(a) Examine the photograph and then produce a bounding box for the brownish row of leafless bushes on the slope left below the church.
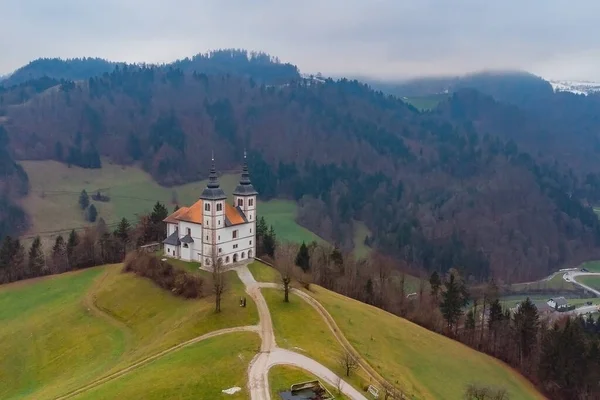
[123,251,204,299]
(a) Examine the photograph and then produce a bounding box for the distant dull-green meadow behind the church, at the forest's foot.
[21,160,324,245]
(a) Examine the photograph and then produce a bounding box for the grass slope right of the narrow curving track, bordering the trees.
[312,285,544,400]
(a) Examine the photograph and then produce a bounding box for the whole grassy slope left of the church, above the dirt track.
[0,266,258,399]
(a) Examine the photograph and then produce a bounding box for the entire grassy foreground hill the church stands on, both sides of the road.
[0,263,542,399]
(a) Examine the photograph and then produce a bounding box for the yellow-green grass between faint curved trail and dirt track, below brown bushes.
[94,266,258,370]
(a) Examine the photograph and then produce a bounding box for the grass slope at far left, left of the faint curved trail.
[0,267,126,399]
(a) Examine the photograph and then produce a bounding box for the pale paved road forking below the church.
[235,265,367,400]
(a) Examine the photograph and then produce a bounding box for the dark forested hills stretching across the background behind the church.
[0,61,600,280]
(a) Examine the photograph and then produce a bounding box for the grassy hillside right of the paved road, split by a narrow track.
[250,263,544,400]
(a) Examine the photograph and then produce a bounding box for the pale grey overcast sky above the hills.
[0,0,600,80]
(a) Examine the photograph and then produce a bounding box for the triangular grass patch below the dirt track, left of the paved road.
[75,332,260,400]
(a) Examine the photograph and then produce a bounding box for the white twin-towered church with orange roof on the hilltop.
[163,153,258,266]
